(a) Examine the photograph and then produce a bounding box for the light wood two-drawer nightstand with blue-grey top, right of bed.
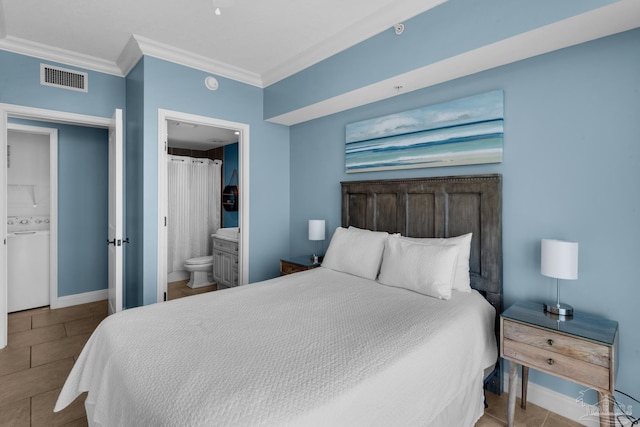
[500,302,618,426]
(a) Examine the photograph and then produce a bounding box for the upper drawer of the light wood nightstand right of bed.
[503,321,611,368]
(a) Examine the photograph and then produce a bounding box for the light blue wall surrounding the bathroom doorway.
[134,56,289,304]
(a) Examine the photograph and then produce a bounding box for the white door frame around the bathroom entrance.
[157,109,249,302]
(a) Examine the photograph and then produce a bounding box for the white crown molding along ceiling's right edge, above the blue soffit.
[262,0,448,87]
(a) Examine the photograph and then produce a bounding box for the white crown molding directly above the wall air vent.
[0,36,123,77]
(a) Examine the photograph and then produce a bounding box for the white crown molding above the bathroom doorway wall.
[130,34,263,88]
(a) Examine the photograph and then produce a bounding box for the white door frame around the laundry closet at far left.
[4,123,60,314]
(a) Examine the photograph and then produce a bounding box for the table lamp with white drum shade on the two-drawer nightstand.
[540,239,578,316]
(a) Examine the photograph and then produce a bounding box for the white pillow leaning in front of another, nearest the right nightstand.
[378,236,459,300]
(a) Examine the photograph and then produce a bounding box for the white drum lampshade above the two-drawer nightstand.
[540,239,578,280]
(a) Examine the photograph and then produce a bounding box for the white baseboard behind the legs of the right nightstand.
[503,373,600,427]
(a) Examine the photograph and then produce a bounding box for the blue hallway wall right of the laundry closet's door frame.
[10,119,109,297]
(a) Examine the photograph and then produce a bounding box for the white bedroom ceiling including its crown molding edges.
[0,0,445,87]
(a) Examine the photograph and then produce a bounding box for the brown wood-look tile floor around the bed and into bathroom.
[0,281,580,427]
